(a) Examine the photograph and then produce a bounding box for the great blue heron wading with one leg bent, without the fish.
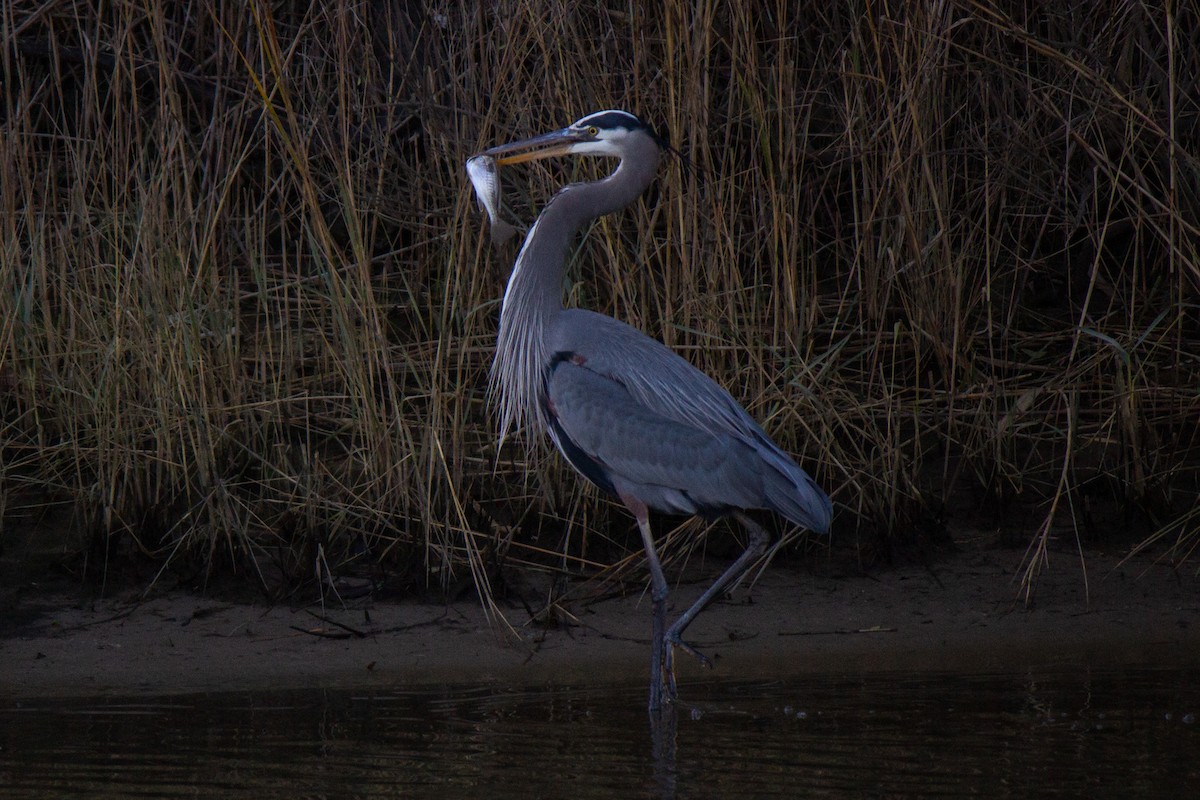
[473,110,832,710]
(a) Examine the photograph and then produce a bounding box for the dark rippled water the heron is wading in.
[0,669,1200,800]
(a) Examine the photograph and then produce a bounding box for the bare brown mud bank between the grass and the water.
[0,551,1200,698]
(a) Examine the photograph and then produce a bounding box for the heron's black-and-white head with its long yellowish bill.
[484,110,676,166]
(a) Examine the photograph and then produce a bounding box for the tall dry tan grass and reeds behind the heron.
[0,0,1200,594]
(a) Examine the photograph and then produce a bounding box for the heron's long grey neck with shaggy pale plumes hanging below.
[490,151,658,444]
